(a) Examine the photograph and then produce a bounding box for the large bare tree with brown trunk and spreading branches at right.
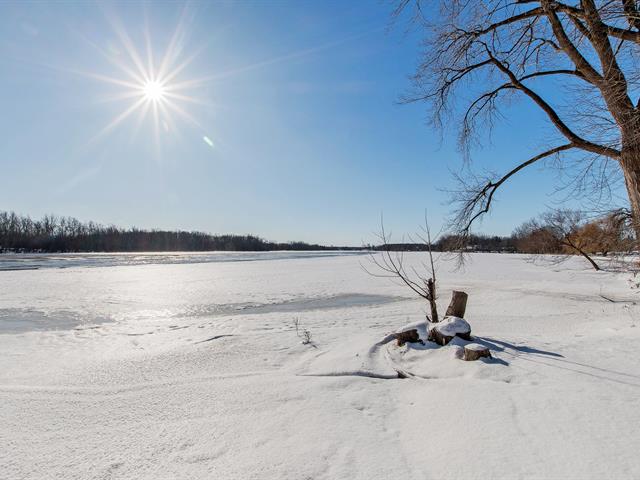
[396,0,640,244]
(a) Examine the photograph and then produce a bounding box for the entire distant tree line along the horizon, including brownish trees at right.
[0,210,635,257]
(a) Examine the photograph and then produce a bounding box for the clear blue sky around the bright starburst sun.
[0,1,620,245]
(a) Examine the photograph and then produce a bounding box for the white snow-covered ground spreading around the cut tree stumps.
[0,254,640,480]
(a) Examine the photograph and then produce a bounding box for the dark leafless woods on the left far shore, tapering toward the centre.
[0,212,360,252]
